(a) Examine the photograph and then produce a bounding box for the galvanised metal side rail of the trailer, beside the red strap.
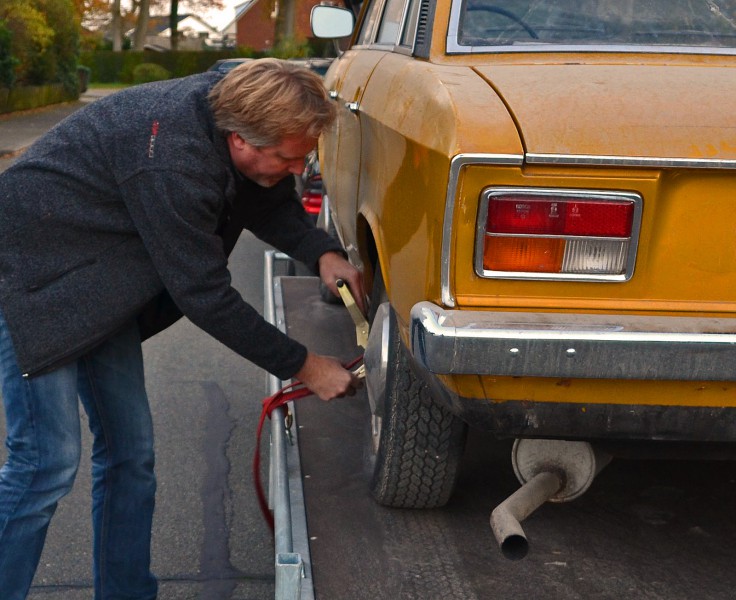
[263,250,314,600]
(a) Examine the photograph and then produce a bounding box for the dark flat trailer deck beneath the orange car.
[267,252,736,600]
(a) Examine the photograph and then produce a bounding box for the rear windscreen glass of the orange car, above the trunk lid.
[455,0,736,50]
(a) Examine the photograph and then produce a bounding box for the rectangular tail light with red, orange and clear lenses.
[476,188,642,281]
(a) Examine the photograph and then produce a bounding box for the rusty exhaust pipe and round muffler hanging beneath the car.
[491,439,611,560]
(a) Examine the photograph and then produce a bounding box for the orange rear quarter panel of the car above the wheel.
[350,54,521,324]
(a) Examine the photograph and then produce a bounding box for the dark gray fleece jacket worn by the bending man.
[0,73,340,379]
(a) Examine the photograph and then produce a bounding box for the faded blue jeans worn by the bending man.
[0,314,157,600]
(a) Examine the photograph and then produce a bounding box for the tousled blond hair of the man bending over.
[208,58,335,147]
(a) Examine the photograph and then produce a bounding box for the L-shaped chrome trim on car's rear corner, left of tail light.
[440,154,524,307]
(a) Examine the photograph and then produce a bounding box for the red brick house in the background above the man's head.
[220,0,341,50]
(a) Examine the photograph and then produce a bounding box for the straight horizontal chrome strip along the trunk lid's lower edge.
[526,152,736,169]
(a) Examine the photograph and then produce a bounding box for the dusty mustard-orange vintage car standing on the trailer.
[313,0,736,507]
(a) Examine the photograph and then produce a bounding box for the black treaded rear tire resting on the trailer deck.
[370,310,467,508]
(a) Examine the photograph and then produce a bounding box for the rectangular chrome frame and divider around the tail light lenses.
[473,186,644,282]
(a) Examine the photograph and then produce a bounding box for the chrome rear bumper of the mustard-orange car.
[411,302,736,381]
